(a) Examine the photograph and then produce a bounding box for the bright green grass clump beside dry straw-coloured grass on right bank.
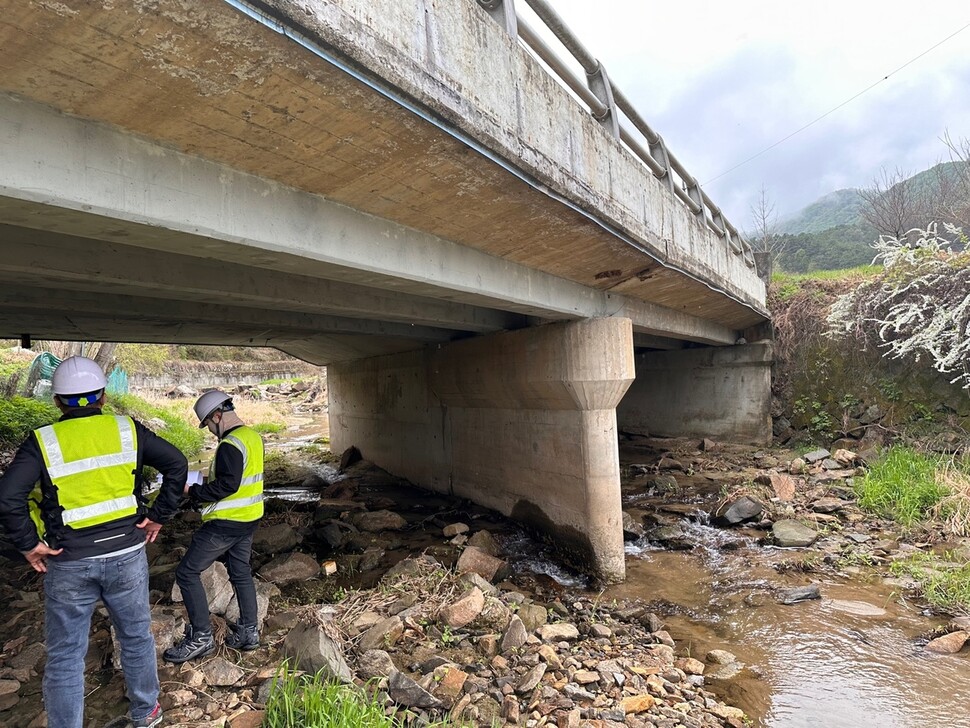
[856,447,950,526]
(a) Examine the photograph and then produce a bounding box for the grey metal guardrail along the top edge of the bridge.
[478,0,755,268]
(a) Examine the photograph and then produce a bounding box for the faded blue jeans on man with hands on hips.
[44,548,158,728]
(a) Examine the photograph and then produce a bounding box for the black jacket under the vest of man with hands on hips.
[0,407,188,561]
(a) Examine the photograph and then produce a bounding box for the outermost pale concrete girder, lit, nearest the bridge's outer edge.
[0,95,737,344]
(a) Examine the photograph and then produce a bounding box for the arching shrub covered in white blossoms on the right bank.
[828,225,970,389]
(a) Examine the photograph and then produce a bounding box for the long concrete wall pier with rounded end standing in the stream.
[328,318,634,581]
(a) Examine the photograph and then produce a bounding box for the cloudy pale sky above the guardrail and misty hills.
[517,0,970,228]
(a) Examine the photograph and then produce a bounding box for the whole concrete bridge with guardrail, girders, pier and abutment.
[0,0,770,579]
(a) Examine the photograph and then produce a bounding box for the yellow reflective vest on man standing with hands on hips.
[34,415,138,529]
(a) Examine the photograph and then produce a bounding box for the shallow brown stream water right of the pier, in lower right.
[602,524,970,728]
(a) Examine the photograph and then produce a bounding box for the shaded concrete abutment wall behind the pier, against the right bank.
[616,343,772,444]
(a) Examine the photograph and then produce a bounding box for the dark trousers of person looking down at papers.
[175,521,257,632]
